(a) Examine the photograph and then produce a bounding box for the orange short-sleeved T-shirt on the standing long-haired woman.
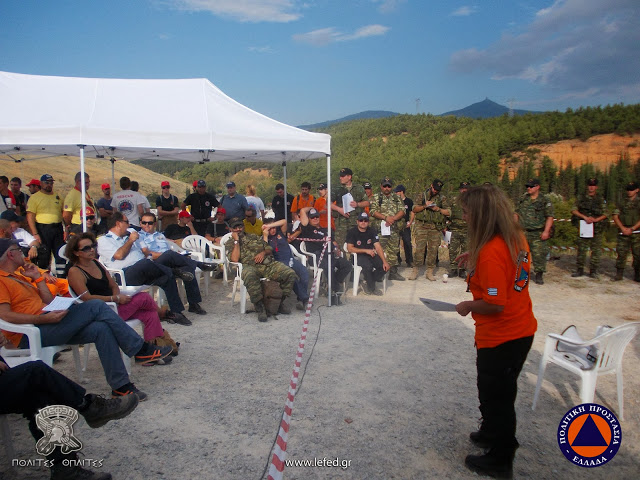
[469,235,538,348]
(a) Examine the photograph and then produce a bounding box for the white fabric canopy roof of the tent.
[0,72,331,162]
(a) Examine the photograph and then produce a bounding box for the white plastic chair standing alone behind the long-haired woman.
[531,322,640,420]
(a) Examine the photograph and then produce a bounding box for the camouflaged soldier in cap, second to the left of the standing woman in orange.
[408,178,451,282]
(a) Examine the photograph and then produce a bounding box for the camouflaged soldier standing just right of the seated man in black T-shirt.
[369,177,405,281]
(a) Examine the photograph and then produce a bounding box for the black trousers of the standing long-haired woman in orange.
[476,335,533,448]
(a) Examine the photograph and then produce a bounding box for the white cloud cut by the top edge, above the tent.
[166,0,302,22]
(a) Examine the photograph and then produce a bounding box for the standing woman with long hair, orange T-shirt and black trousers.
[456,185,537,478]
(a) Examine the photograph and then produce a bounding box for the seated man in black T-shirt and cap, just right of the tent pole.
[347,212,388,295]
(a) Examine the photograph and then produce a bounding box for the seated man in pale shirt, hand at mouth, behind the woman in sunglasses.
[98,212,193,325]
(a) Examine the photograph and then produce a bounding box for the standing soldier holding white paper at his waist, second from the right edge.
[571,178,607,278]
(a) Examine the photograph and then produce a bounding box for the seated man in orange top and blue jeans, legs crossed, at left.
[0,239,172,400]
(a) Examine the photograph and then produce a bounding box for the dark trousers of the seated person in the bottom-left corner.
[0,357,86,463]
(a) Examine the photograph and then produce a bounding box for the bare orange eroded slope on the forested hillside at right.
[501,133,640,176]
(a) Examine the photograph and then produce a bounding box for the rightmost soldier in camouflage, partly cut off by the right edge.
[613,182,640,282]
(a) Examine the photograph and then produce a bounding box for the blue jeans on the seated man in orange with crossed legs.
[20,300,144,389]
